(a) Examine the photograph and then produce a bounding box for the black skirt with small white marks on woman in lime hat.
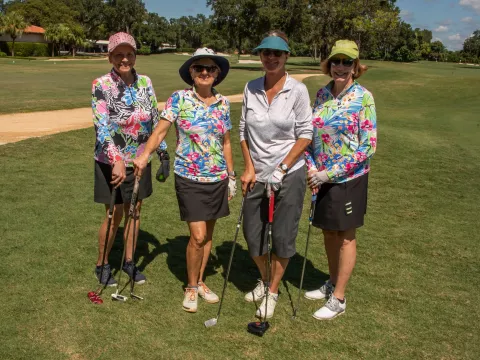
[312,173,368,231]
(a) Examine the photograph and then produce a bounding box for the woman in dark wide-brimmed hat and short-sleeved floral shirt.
[135,48,236,312]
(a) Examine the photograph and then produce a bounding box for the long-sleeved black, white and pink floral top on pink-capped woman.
[92,69,167,166]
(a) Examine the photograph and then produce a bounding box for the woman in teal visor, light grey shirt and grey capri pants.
[240,30,313,319]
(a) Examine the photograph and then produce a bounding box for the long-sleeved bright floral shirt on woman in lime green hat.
[305,81,377,183]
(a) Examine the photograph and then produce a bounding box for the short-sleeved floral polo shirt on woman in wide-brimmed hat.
[161,88,232,182]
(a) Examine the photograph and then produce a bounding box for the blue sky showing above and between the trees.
[144,0,480,50]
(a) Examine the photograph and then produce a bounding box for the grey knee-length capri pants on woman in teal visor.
[243,167,306,258]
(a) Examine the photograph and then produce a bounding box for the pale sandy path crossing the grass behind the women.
[0,74,321,145]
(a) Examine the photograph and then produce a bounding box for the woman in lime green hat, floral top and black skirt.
[305,40,377,320]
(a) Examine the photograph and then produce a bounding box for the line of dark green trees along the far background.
[0,0,480,62]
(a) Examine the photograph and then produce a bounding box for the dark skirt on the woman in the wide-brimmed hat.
[175,174,230,222]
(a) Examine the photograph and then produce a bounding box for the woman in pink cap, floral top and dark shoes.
[92,32,166,286]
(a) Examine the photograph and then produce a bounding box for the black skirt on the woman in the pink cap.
[94,161,153,204]
